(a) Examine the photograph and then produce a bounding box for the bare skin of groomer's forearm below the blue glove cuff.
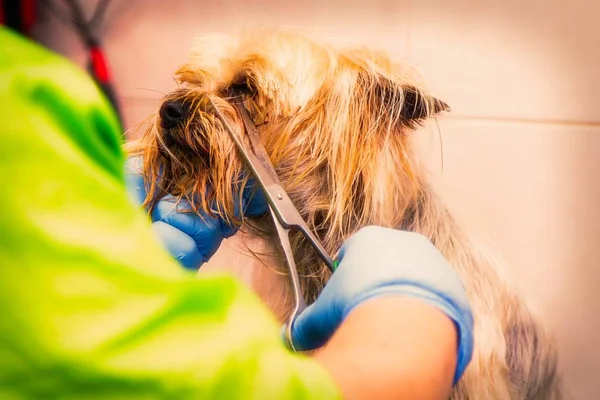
[313,296,457,400]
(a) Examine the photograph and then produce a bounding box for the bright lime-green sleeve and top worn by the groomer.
[0,28,339,399]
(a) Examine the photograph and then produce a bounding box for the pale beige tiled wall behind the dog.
[38,0,600,400]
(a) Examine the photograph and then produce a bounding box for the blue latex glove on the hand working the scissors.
[292,226,473,383]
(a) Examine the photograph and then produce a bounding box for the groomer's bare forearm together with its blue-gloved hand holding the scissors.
[292,227,473,400]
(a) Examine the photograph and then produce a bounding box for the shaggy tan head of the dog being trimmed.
[132,31,448,300]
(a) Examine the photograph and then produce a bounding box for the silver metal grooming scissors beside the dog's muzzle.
[207,96,337,351]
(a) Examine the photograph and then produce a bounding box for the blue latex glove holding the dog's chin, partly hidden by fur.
[125,156,268,270]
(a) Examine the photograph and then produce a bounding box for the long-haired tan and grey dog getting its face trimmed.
[127,30,562,400]
